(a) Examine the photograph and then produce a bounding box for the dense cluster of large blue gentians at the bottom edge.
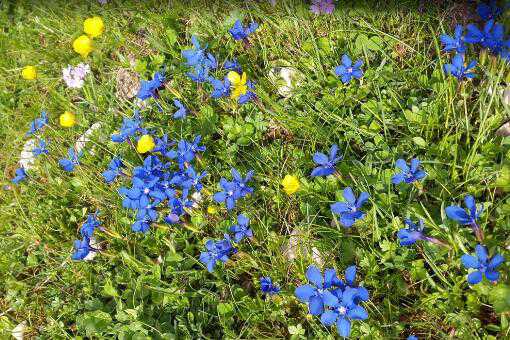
[295,266,369,337]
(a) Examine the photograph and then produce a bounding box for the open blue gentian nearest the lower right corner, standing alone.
[461,244,505,285]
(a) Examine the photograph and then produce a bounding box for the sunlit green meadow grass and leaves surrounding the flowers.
[0,1,510,339]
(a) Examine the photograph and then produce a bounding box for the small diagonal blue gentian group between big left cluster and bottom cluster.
[200,214,253,272]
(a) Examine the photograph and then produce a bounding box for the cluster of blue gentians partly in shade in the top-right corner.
[440,1,510,80]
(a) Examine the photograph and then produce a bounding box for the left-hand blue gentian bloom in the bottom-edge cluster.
[294,266,341,315]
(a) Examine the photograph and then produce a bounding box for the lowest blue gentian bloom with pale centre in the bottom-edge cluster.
[321,287,368,337]
